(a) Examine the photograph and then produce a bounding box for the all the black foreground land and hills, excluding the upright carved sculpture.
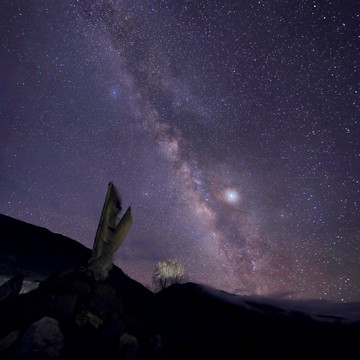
[0,215,360,360]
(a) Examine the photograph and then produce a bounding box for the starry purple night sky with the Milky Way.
[0,0,360,302]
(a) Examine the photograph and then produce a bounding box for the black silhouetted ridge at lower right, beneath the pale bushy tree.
[155,283,360,360]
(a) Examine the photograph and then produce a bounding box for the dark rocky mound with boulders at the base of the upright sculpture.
[0,269,165,359]
